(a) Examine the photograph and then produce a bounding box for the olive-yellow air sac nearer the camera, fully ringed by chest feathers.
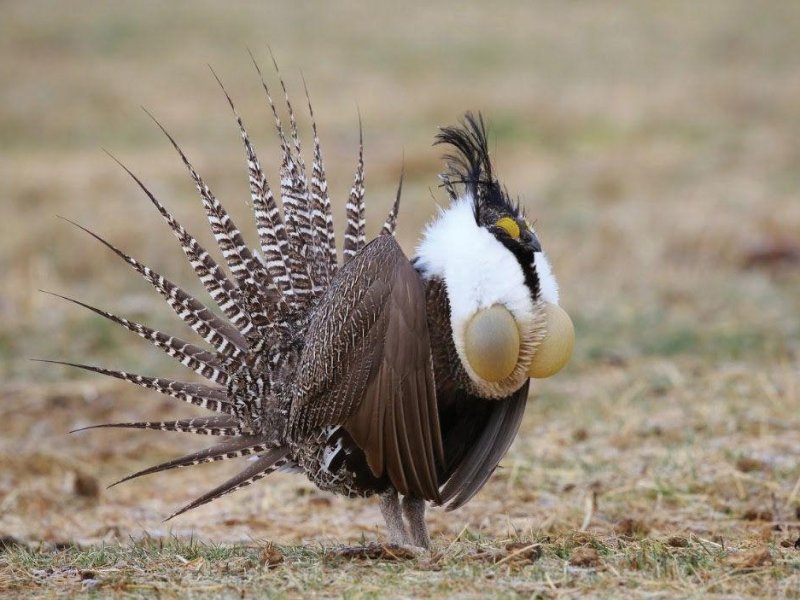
[464,304,519,382]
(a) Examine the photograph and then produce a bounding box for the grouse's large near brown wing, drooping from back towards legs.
[291,236,444,501]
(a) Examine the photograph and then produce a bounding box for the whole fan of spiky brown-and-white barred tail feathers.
[50,59,402,519]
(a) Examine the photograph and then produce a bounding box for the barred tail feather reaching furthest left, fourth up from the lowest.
[36,359,235,415]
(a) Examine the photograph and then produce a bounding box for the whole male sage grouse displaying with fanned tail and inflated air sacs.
[47,64,574,547]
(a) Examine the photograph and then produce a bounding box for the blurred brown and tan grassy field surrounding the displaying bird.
[0,0,800,598]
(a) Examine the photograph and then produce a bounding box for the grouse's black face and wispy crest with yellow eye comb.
[436,113,542,301]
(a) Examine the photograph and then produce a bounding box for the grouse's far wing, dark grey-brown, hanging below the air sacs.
[441,381,530,510]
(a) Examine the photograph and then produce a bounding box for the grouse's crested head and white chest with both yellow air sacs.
[415,113,575,398]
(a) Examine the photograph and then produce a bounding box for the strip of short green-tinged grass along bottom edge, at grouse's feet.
[3,529,799,597]
